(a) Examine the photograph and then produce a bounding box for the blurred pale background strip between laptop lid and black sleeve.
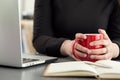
[20,0,35,54]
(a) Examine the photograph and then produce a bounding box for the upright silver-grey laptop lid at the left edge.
[0,0,21,66]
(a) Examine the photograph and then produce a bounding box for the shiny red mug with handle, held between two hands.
[72,34,103,62]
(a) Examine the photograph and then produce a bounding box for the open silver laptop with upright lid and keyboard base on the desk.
[0,0,57,67]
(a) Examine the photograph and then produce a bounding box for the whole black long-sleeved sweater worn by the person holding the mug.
[33,0,120,57]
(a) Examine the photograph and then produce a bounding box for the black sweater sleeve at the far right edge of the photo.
[108,0,120,59]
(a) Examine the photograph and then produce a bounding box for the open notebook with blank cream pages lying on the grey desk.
[43,60,120,79]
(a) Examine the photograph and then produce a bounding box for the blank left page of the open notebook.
[47,61,97,73]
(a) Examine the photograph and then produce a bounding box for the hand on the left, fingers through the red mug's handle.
[60,33,90,60]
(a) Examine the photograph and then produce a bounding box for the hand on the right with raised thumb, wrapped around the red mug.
[89,29,119,60]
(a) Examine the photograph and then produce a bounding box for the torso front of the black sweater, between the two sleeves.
[52,0,115,39]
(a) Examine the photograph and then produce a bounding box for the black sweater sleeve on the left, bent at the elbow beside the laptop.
[33,0,66,57]
